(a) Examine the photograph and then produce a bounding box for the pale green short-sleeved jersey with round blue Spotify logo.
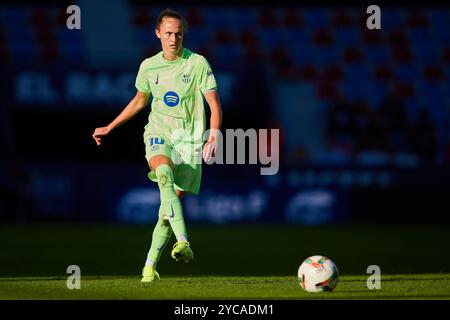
[135,49,217,144]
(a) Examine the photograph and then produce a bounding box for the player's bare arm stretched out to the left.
[92,91,150,146]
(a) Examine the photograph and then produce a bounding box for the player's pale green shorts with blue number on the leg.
[144,131,202,194]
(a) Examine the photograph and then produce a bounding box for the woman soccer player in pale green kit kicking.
[93,9,222,282]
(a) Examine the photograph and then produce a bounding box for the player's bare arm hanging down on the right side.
[203,90,222,162]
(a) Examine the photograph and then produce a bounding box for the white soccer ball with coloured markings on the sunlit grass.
[297,256,339,292]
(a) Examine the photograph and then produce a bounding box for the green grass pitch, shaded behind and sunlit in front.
[0,225,450,300]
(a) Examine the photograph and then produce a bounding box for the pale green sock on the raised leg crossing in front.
[156,164,187,241]
